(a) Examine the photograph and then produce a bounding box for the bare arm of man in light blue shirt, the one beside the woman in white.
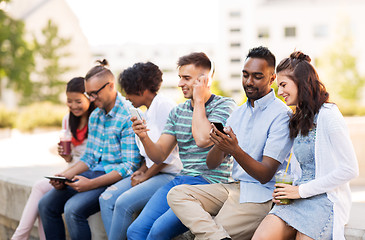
[210,126,280,184]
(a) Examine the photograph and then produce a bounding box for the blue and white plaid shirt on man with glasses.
[81,93,141,178]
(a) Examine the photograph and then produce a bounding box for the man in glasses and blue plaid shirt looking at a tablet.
[39,60,141,240]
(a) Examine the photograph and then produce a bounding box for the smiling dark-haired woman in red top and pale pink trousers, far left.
[11,77,94,240]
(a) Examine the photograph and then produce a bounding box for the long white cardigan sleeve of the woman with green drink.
[299,107,359,198]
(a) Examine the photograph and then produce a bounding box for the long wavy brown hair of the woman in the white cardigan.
[276,51,329,138]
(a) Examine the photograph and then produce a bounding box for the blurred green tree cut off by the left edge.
[0,1,34,97]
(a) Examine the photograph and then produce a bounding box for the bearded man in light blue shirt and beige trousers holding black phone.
[168,47,292,240]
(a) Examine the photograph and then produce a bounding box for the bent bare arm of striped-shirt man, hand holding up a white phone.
[131,117,177,164]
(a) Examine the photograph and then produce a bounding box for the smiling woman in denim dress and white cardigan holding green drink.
[253,52,359,240]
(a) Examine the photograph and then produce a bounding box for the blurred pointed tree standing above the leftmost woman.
[32,20,71,103]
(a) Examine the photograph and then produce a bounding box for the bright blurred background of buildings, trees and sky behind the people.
[0,0,365,171]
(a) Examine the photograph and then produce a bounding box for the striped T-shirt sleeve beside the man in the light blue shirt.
[208,97,236,126]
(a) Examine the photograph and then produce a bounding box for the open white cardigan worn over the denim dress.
[292,103,359,240]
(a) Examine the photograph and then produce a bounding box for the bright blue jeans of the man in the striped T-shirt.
[127,176,209,240]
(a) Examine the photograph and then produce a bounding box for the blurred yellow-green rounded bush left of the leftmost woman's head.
[16,102,67,131]
